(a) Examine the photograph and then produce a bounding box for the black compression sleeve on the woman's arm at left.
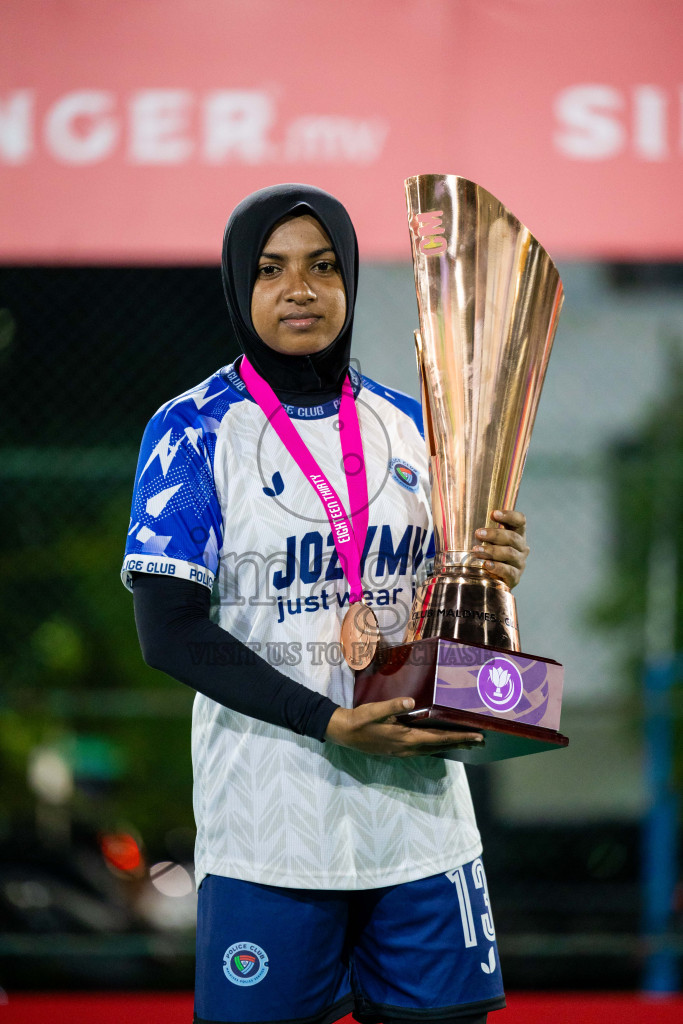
[133,572,338,740]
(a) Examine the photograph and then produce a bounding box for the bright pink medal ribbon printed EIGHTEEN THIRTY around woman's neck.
[240,355,369,604]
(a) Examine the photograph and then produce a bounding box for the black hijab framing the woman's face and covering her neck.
[222,184,358,406]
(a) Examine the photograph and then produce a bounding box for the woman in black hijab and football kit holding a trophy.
[123,184,528,1024]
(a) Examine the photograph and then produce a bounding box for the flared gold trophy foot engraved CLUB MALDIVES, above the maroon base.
[404,565,520,650]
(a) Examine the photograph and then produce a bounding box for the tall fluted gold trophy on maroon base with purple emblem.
[354,174,568,763]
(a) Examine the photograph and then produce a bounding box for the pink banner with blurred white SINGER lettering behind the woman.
[0,0,683,263]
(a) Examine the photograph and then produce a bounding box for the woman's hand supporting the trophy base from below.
[325,697,483,758]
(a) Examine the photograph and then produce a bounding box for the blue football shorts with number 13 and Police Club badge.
[195,857,505,1024]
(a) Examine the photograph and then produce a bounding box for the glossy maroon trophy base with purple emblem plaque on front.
[353,637,569,764]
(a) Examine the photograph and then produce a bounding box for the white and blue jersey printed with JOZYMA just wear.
[122,367,480,889]
